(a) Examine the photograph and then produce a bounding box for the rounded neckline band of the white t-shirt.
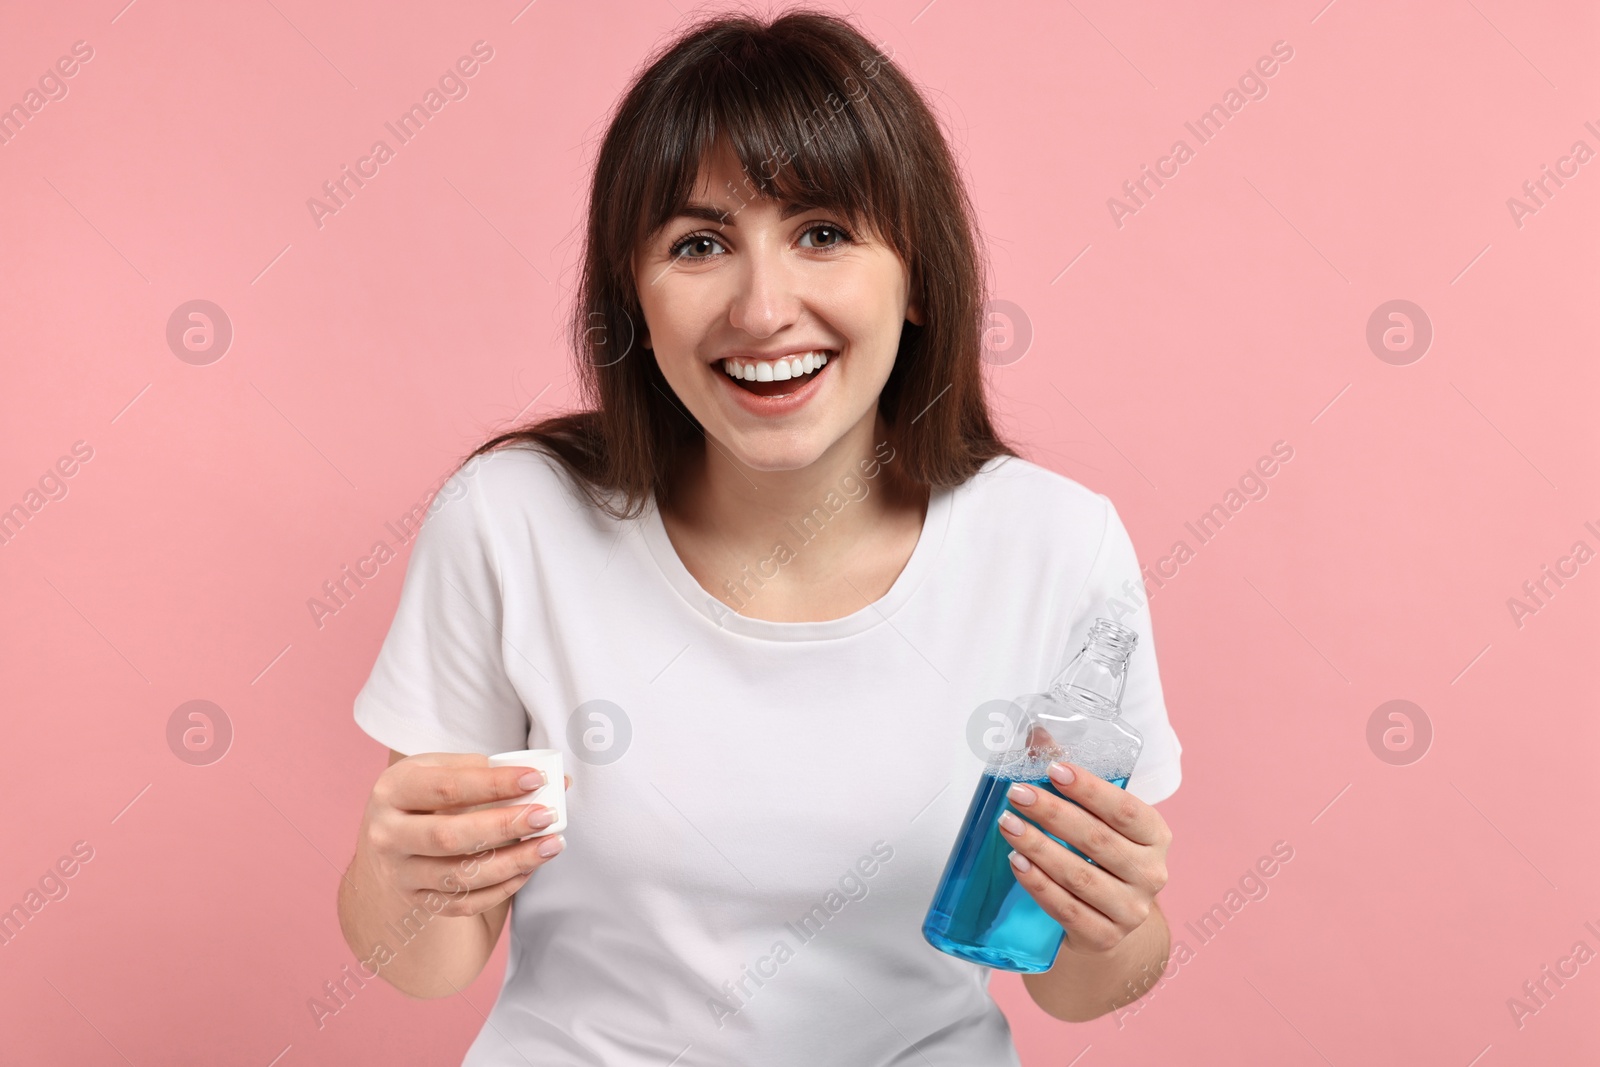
[640,476,957,641]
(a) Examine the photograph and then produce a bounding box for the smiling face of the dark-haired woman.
[634,150,922,470]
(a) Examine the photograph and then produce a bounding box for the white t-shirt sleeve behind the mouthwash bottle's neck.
[1062,494,1182,805]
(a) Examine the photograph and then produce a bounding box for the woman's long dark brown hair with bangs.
[467,10,1016,518]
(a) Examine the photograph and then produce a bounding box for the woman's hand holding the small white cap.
[355,752,573,915]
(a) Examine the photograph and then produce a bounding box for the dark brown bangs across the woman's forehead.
[635,25,914,254]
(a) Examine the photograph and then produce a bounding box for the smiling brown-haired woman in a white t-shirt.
[339,13,1181,1067]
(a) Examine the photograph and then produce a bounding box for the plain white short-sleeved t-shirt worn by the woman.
[355,450,1182,1067]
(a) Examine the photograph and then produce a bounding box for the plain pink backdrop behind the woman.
[0,0,1600,1067]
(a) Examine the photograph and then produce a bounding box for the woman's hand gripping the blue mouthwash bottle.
[1000,763,1173,955]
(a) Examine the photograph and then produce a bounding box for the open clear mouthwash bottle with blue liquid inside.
[922,619,1144,973]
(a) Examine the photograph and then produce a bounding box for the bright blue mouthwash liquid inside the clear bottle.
[922,758,1128,973]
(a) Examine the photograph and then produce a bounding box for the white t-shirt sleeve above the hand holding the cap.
[355,466,530,755]
